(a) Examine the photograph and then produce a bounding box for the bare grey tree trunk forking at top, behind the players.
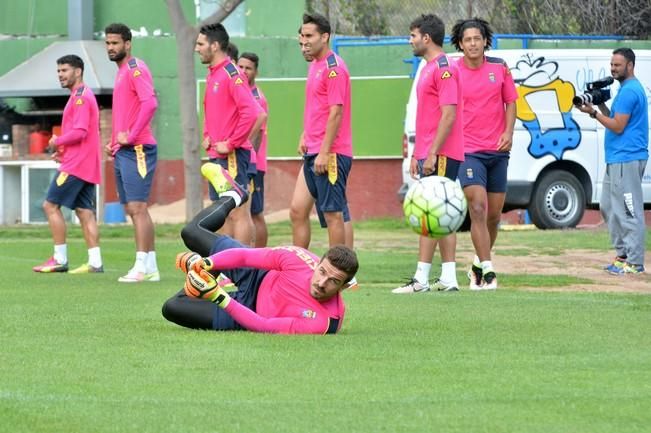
[165,0,243,221]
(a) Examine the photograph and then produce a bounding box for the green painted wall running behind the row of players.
[0,0,651,159]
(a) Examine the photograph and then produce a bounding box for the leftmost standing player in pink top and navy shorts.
[33,54,104,274]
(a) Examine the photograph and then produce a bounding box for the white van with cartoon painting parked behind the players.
[398,49,651,229]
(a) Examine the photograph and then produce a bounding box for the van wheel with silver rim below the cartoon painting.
[529,170,585,229]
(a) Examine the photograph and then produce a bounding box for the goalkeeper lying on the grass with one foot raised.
[163,163,358,334]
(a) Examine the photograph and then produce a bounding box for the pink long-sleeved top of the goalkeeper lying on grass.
[210,246,346,334]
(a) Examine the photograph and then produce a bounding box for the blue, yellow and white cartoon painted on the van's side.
[511,54,581,160]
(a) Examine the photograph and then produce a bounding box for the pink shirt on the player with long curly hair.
[457,57,518,153]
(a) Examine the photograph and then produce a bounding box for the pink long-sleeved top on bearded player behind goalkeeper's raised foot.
[203,57,259,159]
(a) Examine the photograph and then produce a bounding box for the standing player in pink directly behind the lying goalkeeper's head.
[290,14,352,253]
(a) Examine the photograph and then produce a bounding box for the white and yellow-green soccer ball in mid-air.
[402,176,468,238]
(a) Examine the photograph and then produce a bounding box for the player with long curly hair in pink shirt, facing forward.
[451,18,518,290]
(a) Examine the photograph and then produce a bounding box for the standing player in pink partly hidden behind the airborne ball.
[393,15,463,293]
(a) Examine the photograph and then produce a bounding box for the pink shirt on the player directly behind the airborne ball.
[414,54,463,161]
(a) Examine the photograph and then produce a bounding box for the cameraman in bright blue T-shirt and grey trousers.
[578,48,649,275]
